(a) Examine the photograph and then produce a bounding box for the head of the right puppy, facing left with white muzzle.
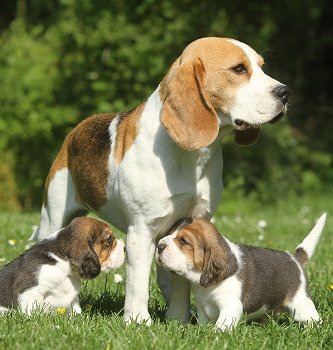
[156,219,237,288]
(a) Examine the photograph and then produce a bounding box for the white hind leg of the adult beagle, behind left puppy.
[30,168,88,240]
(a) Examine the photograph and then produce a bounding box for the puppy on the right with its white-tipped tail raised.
[156,214,326,330]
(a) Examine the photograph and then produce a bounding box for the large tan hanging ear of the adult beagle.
[161,58,219,151]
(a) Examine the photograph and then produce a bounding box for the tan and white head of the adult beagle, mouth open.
[160,38,288,150]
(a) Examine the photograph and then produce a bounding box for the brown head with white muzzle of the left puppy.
[59,217,125,278]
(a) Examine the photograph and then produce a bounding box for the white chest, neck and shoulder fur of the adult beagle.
[99,94,223,234]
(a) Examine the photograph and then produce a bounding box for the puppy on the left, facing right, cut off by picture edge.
[0,217,124,315]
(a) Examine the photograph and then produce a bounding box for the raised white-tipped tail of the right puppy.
[294,213,326,267]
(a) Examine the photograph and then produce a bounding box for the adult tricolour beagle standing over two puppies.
[32,37,288,323]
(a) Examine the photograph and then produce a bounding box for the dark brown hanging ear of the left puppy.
[71,241,101,279]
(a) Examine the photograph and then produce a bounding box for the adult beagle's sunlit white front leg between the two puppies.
[124,225,155,324]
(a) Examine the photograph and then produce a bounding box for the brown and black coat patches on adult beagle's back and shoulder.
[44,104,144,210]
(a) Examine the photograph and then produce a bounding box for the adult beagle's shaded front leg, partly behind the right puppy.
[166,274,191,323]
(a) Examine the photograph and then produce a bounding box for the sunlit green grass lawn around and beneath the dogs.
[0,194,333,350]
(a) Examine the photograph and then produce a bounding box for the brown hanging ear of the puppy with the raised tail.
[200,247,227,288]
